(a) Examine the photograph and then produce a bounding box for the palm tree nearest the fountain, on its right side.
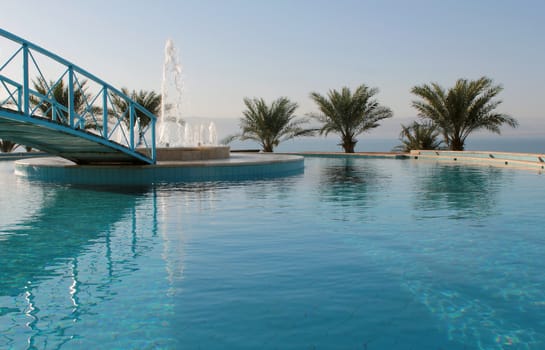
[223,97,314,152]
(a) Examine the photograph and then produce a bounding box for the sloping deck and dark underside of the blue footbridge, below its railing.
[0,108,146,164]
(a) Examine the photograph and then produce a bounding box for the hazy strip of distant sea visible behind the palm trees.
[230,136,545,153]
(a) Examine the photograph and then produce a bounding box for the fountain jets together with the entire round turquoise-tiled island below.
[10,40,304,186]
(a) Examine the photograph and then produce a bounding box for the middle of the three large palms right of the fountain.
[310,84,393,153]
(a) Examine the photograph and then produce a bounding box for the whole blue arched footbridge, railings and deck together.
[0,29,156,164]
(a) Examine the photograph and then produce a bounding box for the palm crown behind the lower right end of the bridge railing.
[112,88,162,129]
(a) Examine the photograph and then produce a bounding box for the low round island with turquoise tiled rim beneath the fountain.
[15,147,304,186]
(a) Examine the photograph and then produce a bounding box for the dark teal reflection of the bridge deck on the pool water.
[0,187,149,295]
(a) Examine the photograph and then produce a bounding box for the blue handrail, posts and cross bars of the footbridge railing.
[0,28,157,163]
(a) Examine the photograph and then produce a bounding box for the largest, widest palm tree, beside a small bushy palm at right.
[411,77,518,151]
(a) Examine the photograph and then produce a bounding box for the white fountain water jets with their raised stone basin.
[157,39,229,161]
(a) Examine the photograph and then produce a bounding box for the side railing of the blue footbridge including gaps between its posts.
[0,29,157,163]
